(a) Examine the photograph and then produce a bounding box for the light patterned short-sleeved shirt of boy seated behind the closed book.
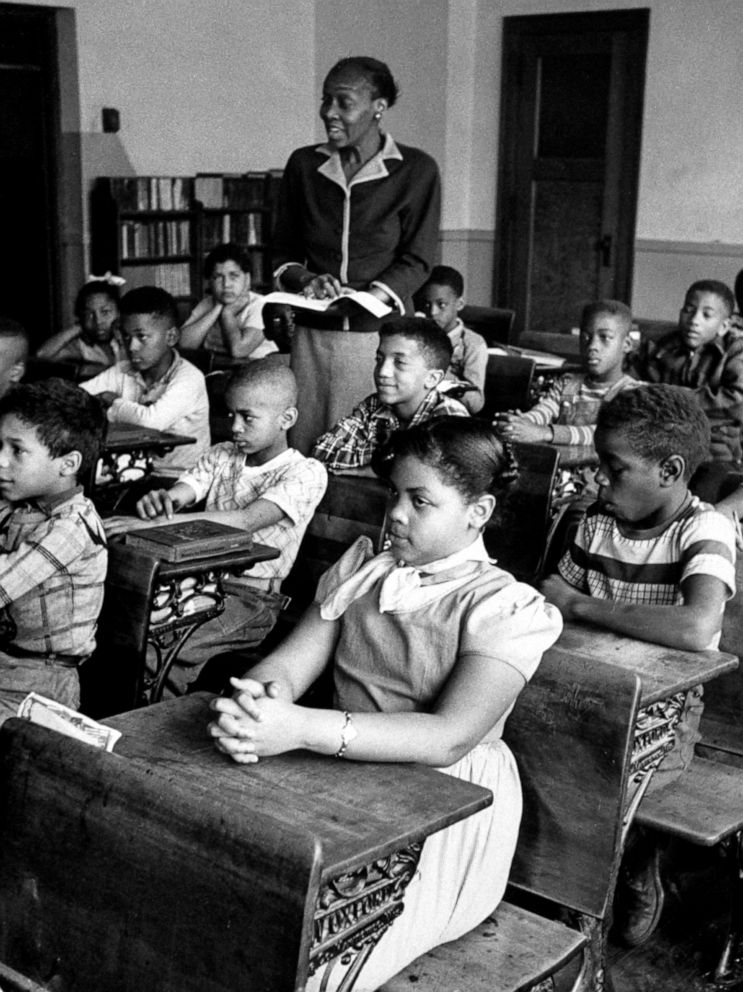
[178,441,328,585]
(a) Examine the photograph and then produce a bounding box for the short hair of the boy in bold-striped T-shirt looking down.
[596,383,710,479]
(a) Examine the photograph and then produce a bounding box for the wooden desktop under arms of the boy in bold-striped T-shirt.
[549,623,738,706]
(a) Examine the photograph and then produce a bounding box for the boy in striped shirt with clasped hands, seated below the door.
[496,300,637,445]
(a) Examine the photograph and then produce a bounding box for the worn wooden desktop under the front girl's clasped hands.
[104,693,492,880]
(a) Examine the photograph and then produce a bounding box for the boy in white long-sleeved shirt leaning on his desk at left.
[82,286,210,476]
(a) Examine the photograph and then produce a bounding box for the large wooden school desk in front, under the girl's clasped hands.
[0,693,492,992]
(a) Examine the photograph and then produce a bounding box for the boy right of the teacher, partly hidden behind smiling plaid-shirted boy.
[415,265,488,413]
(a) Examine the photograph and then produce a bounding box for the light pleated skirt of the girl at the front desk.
[307,741,521,992]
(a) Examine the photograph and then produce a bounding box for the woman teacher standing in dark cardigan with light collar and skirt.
[273,56,441,453]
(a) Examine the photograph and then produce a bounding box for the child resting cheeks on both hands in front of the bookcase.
[181,242,278,361]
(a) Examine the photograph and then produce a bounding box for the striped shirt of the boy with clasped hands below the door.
[519,372,640,445]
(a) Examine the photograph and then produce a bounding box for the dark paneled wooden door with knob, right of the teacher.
[495,9,648,334]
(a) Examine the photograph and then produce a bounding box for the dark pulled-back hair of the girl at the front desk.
[372,417,518,503]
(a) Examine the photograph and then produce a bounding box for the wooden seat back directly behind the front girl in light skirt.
[504,652,640,919]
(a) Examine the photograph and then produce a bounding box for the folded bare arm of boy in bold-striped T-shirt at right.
[542,574,728,651]
